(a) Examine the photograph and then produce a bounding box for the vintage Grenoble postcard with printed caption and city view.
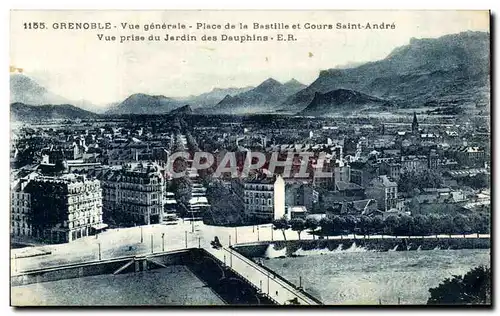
[9,10,492,307]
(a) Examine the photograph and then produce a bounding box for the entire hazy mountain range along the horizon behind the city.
[10,32,490,117]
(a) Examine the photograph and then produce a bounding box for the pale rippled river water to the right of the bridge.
[263,245,490,304]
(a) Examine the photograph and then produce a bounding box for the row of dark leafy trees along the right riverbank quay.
[273,214,490,240]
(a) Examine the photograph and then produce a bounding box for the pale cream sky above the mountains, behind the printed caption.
[10,10,489,105]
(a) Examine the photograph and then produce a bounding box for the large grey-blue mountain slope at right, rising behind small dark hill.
[282,32,490,110]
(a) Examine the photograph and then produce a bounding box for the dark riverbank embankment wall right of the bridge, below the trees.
[233,238,490,258]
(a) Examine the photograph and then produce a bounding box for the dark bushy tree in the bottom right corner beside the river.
[427,266,491,305]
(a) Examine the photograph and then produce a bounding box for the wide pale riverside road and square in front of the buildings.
[11,220,489,274]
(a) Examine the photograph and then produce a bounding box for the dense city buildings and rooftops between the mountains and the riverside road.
[11,114,490,243]
